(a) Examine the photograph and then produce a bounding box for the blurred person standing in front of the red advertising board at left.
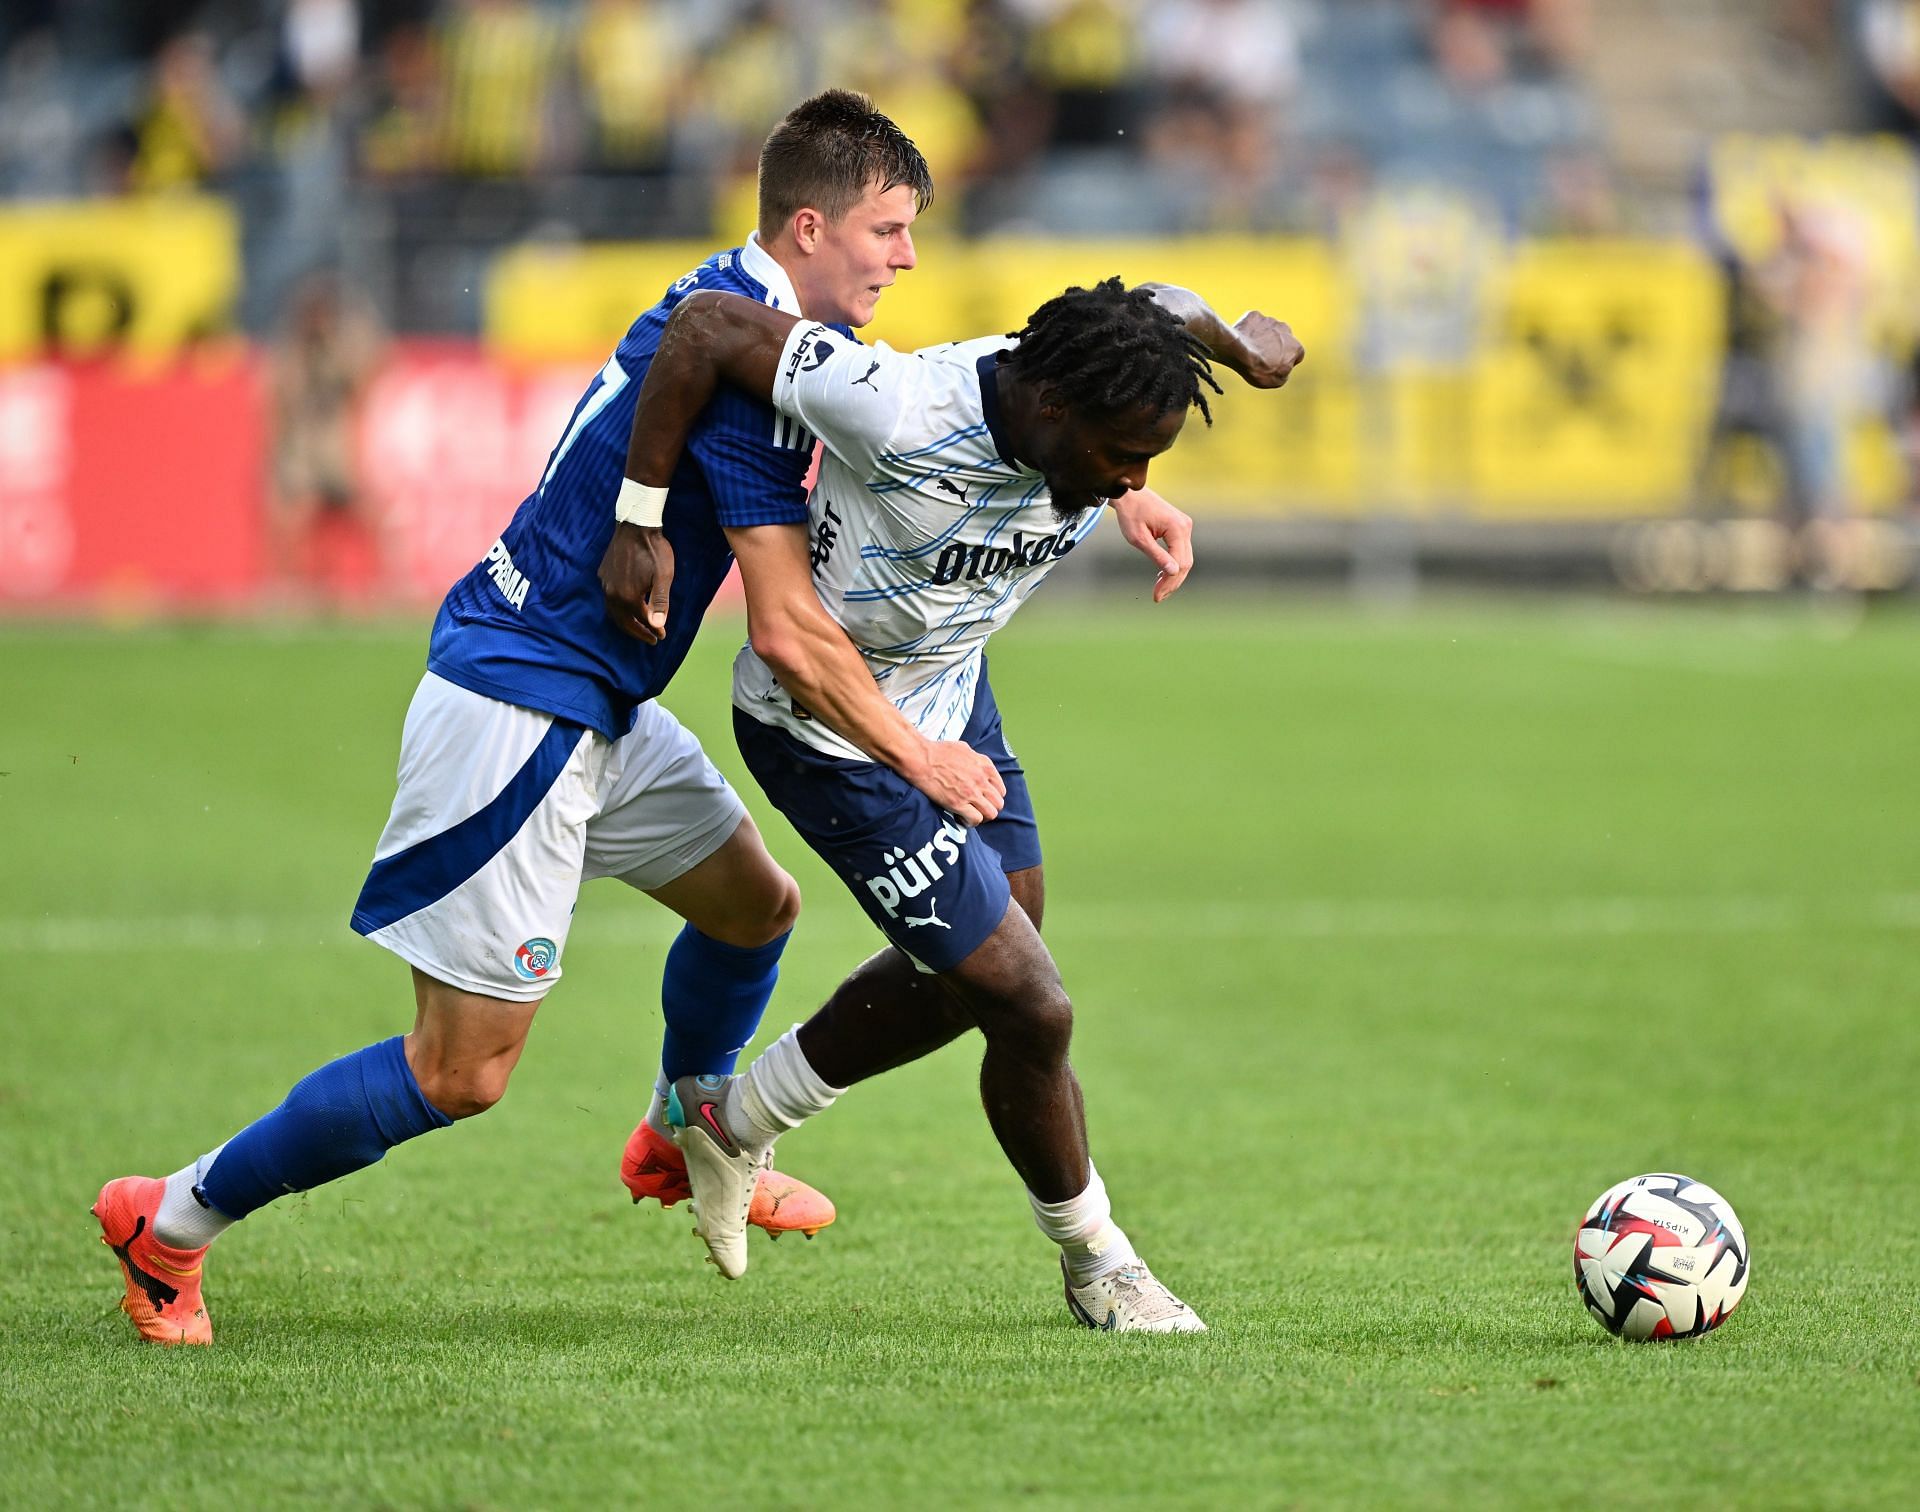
[267,272,384,606]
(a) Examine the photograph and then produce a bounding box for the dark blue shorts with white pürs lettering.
[733,668,1041,971]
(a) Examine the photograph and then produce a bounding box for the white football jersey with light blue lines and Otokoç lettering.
[733,324,1106,762]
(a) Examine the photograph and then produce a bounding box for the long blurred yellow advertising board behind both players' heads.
[488,238,1766,518]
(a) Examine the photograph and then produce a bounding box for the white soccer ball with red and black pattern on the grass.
[1572,1172,1747,1339]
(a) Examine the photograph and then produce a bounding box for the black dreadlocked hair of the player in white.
[1008,278,1219,426]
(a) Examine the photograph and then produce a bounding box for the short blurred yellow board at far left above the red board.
[0,196,240,361]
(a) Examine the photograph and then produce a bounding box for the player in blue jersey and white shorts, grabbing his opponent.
[94,92,1067,1343]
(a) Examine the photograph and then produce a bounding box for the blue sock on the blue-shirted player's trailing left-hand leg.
[198,1034,453,1218]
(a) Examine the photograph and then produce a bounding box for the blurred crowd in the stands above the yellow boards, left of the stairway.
[0,0,1613,328]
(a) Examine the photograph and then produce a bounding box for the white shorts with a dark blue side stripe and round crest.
[353,672,747,1002]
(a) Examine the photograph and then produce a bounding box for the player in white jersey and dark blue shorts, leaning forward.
[603,280,1304,1332]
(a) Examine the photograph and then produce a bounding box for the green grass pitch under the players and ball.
[0,587,1920,1508]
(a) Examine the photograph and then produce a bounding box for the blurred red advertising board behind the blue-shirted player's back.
[0,342,744,614]
